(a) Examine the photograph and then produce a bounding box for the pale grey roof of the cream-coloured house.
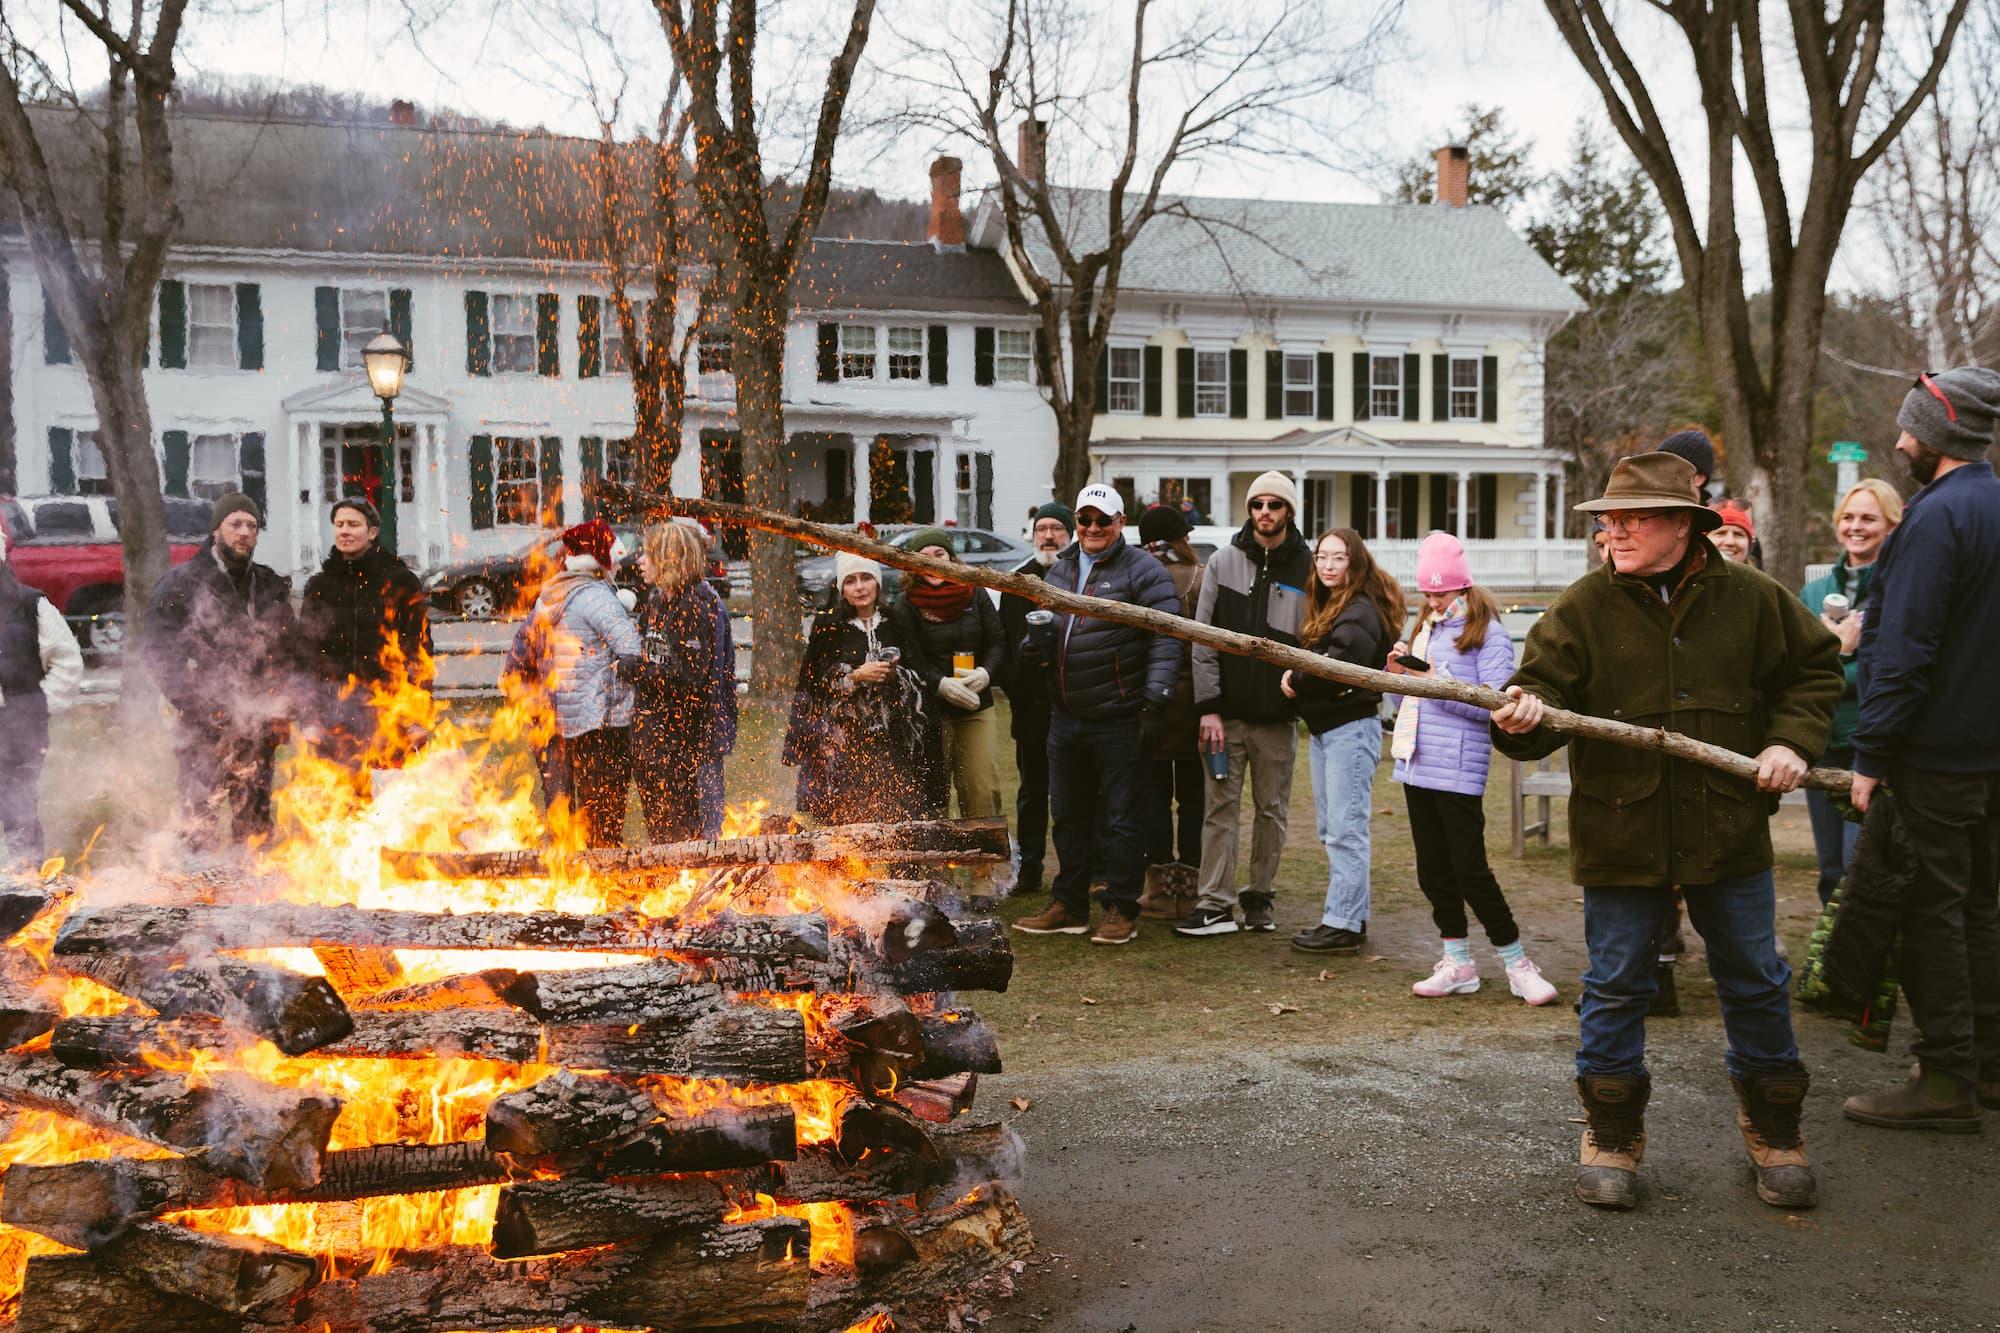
[972,188,1584,314]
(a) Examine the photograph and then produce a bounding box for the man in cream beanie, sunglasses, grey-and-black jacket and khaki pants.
[1174,472,1312,932]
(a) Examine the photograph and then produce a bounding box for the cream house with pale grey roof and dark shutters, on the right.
[972,148,1584,588]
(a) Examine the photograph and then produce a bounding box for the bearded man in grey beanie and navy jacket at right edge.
[1844,368,2000,1133]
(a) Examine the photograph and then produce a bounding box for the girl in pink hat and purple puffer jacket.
[1386,532,1556,1005]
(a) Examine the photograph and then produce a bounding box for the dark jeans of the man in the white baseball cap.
[1048,709,1146,917]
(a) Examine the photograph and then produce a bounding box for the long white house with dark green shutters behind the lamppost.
[0,112,1054,576]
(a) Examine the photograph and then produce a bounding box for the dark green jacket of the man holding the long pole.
[1492,536,1844,887]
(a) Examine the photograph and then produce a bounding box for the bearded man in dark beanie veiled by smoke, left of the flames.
[144,492,298,847]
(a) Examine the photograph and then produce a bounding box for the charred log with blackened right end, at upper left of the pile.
[58,955,354,1055]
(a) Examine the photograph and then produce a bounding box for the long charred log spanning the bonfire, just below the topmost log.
[56,903,826,959]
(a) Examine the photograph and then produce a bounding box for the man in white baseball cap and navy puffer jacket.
[1014,484,1186,945]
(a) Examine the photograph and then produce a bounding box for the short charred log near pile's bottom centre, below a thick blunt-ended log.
[492,1173,752,1259]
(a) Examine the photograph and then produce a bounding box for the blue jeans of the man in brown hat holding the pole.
[1576,871,1804,1079]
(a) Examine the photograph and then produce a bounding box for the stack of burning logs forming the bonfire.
[0,821,1032,1333]
